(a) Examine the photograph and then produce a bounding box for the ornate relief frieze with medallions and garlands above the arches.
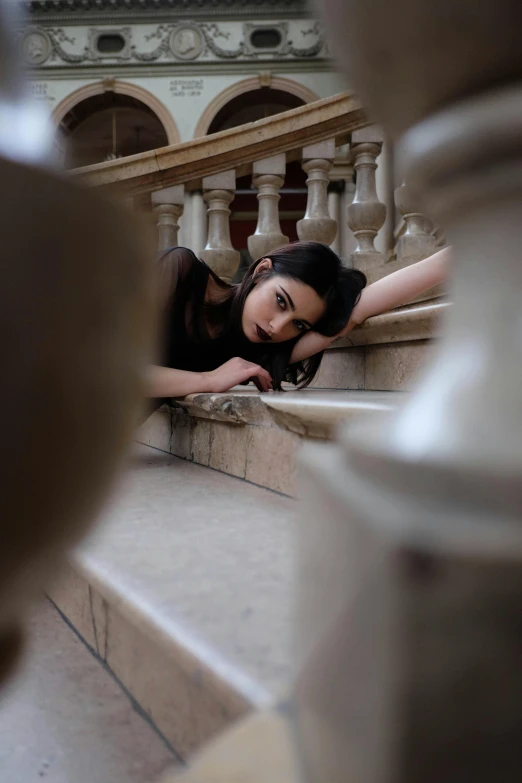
[19,20,327,67]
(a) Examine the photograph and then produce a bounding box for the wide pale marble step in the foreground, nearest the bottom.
[49,447,296,759]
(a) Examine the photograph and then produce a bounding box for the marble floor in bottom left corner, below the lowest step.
[0,601,176,783]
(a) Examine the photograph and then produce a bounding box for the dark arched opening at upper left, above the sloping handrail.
[59,91,169,168]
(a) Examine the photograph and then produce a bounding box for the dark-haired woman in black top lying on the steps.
[148,242,449,398]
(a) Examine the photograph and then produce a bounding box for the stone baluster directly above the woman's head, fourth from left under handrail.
[297,139,337,245]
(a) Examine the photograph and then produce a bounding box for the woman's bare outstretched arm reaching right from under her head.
[290,247,451,363]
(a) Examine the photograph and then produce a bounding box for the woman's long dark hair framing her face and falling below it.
[205,242,366,390]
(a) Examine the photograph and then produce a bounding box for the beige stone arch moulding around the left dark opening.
[52,79,180,144]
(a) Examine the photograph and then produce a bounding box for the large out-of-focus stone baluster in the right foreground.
[298,0,522,783]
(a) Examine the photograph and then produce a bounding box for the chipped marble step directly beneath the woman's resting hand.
[136,387,404,496]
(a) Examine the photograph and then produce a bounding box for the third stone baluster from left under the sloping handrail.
[248,154,288,261]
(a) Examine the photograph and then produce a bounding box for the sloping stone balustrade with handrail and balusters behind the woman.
[77,94,437,281]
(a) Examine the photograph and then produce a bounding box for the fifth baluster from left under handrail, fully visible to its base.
[346,125,386,271]
